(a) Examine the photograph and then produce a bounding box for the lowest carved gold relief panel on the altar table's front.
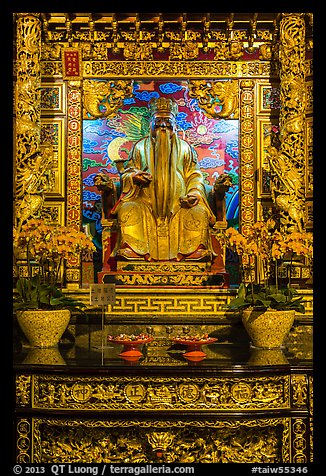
[33,418,290,463]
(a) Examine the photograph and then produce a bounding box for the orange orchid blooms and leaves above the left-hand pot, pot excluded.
[13,218,96,310]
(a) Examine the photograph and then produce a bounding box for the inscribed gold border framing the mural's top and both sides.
[59,60,264,287]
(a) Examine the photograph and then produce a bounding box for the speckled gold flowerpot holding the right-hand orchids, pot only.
[241,309,295,349]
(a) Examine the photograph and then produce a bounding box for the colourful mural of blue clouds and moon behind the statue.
[83,81,239,282]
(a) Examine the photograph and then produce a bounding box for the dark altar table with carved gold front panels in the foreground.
[14,325,313,466]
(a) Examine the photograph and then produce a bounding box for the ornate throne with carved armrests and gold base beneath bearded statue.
[94,170,232,288]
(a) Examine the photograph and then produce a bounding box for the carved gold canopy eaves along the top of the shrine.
[34,12,312,48]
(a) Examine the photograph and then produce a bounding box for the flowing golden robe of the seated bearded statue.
[113,135,215,260]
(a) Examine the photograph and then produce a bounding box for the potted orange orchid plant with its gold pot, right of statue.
[222,219,313,348]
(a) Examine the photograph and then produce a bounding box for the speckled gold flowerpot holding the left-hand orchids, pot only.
[17,309,70,347]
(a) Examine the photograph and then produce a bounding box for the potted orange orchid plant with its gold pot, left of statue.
[13,218,95,347]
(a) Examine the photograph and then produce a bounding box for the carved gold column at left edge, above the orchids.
[14,13,41,221]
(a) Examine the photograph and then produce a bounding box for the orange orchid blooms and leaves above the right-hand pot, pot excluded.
[221,219,313,313]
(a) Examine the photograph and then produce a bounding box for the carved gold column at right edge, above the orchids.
[268,13,306,231]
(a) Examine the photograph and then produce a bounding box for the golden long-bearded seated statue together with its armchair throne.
[94,98,232,281]
